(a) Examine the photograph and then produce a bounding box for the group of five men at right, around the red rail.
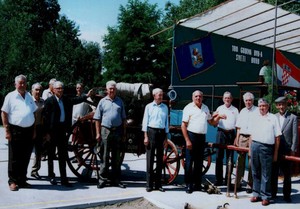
[181,91,298,206]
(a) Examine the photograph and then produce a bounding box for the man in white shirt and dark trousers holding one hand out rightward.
[181,90,220,194]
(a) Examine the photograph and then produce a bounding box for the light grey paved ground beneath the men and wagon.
[0,125,300,209]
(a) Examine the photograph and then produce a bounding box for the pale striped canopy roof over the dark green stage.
[178,0,300,55]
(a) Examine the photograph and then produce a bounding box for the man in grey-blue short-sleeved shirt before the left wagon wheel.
[94,81,126,189]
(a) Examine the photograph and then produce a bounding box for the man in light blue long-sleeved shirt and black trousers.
[142,88,169,192]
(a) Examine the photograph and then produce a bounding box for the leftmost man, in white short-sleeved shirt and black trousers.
[1,75,37,191]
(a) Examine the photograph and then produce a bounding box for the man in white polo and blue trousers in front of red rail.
[249,98,281,206]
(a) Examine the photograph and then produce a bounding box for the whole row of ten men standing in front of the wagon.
[1,75,298,206]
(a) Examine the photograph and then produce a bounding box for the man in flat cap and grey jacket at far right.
[272,97,298,202]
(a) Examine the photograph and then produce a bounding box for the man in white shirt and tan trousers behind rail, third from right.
[234,92,258,193]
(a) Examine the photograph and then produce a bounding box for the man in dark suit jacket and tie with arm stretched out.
[44,81,91,187]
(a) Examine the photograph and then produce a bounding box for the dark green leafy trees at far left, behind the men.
[0,0,101,97]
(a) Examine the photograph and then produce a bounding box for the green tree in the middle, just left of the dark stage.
[103,0,172,87]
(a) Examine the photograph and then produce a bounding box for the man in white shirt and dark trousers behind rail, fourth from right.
[215,91,239,186]
